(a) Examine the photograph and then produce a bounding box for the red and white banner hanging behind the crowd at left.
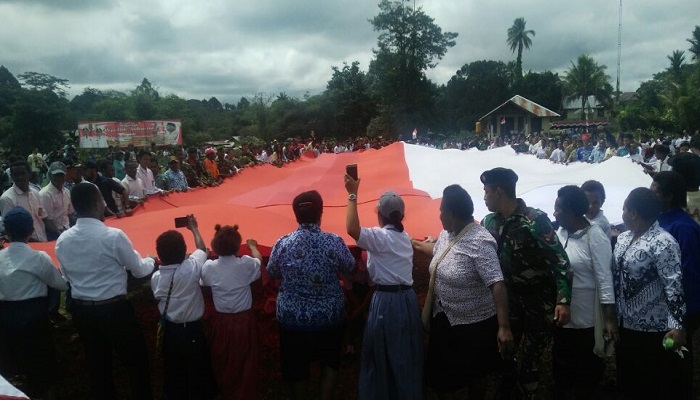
[77,119,182,149]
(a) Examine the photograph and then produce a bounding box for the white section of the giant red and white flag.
[404,144,652,224]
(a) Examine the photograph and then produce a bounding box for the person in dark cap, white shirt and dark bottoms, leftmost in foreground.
[0,207,68,398]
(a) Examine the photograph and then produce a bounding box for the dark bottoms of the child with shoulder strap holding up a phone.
[163,321,216,400]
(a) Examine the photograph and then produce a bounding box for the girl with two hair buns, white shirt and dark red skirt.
[202,225,262,399]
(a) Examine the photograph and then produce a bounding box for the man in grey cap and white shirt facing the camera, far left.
[39,161,73,240]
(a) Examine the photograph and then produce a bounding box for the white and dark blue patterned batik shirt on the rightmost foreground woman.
[613,222,685,332]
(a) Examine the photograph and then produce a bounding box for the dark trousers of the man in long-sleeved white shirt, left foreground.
[71,300,153,400]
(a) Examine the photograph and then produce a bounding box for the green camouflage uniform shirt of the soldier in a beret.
[481,199,572,310]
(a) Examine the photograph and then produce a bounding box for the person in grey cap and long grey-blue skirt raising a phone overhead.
[345,180,423,400]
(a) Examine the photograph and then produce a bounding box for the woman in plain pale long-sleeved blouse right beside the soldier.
[552,185,617,399]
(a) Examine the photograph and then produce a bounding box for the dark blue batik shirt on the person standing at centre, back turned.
[266,224,355,331]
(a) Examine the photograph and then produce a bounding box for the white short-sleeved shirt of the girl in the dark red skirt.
[202,256,261,313]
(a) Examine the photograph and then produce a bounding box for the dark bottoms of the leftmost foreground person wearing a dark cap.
[0,297,56,397]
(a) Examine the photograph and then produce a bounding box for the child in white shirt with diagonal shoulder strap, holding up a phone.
[151,215,216,400]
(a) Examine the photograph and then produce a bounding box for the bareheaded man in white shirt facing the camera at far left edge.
[0,161,47,242]
